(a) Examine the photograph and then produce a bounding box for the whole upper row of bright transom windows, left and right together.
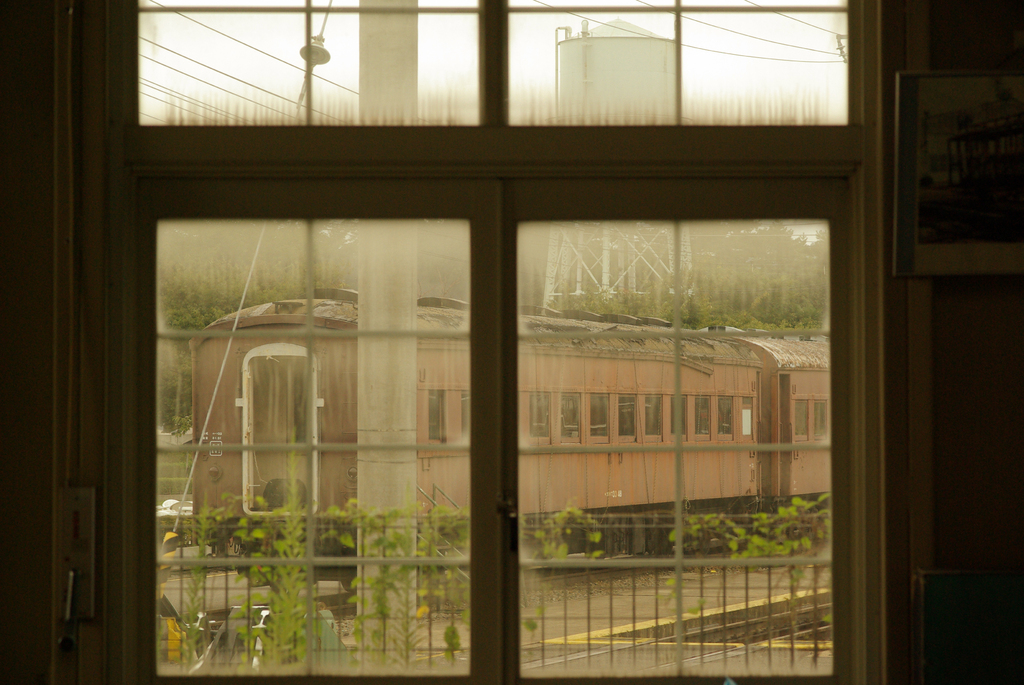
[137,0,849,126]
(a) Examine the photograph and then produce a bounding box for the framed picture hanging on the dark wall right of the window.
[894,72,1024,275]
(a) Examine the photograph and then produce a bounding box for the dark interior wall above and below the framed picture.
[925,5,1024,569]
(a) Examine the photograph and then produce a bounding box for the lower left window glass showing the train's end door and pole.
[156,219,470,675]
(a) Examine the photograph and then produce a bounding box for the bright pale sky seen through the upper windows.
[139,0,848,124]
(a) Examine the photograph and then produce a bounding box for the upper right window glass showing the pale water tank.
[509,9,849,126]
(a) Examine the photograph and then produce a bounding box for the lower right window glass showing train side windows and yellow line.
[517,220,833,678]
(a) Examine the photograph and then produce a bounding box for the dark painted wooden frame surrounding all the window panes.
[103,0,888,685]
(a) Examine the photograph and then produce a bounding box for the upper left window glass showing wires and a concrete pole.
[139,0,479,126]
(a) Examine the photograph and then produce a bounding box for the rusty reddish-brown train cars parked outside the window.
[190,291,830,553]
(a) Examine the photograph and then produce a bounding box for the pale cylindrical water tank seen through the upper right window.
[558,18,676,125]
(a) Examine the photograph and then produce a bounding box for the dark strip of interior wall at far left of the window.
[0,2,55,683]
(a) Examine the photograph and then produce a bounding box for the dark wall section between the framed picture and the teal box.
[933,275,1024,570]
